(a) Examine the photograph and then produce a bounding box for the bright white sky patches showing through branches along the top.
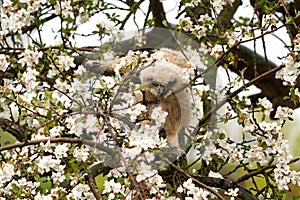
[37,0,289,64]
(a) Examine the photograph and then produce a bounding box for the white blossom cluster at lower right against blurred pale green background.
[223,94,300,190]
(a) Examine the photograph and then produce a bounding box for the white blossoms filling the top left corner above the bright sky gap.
[0,0,105,40]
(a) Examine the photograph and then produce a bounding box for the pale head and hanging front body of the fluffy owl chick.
[139,62,191,147]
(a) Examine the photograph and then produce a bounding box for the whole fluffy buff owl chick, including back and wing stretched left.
[86,48,191,147]
